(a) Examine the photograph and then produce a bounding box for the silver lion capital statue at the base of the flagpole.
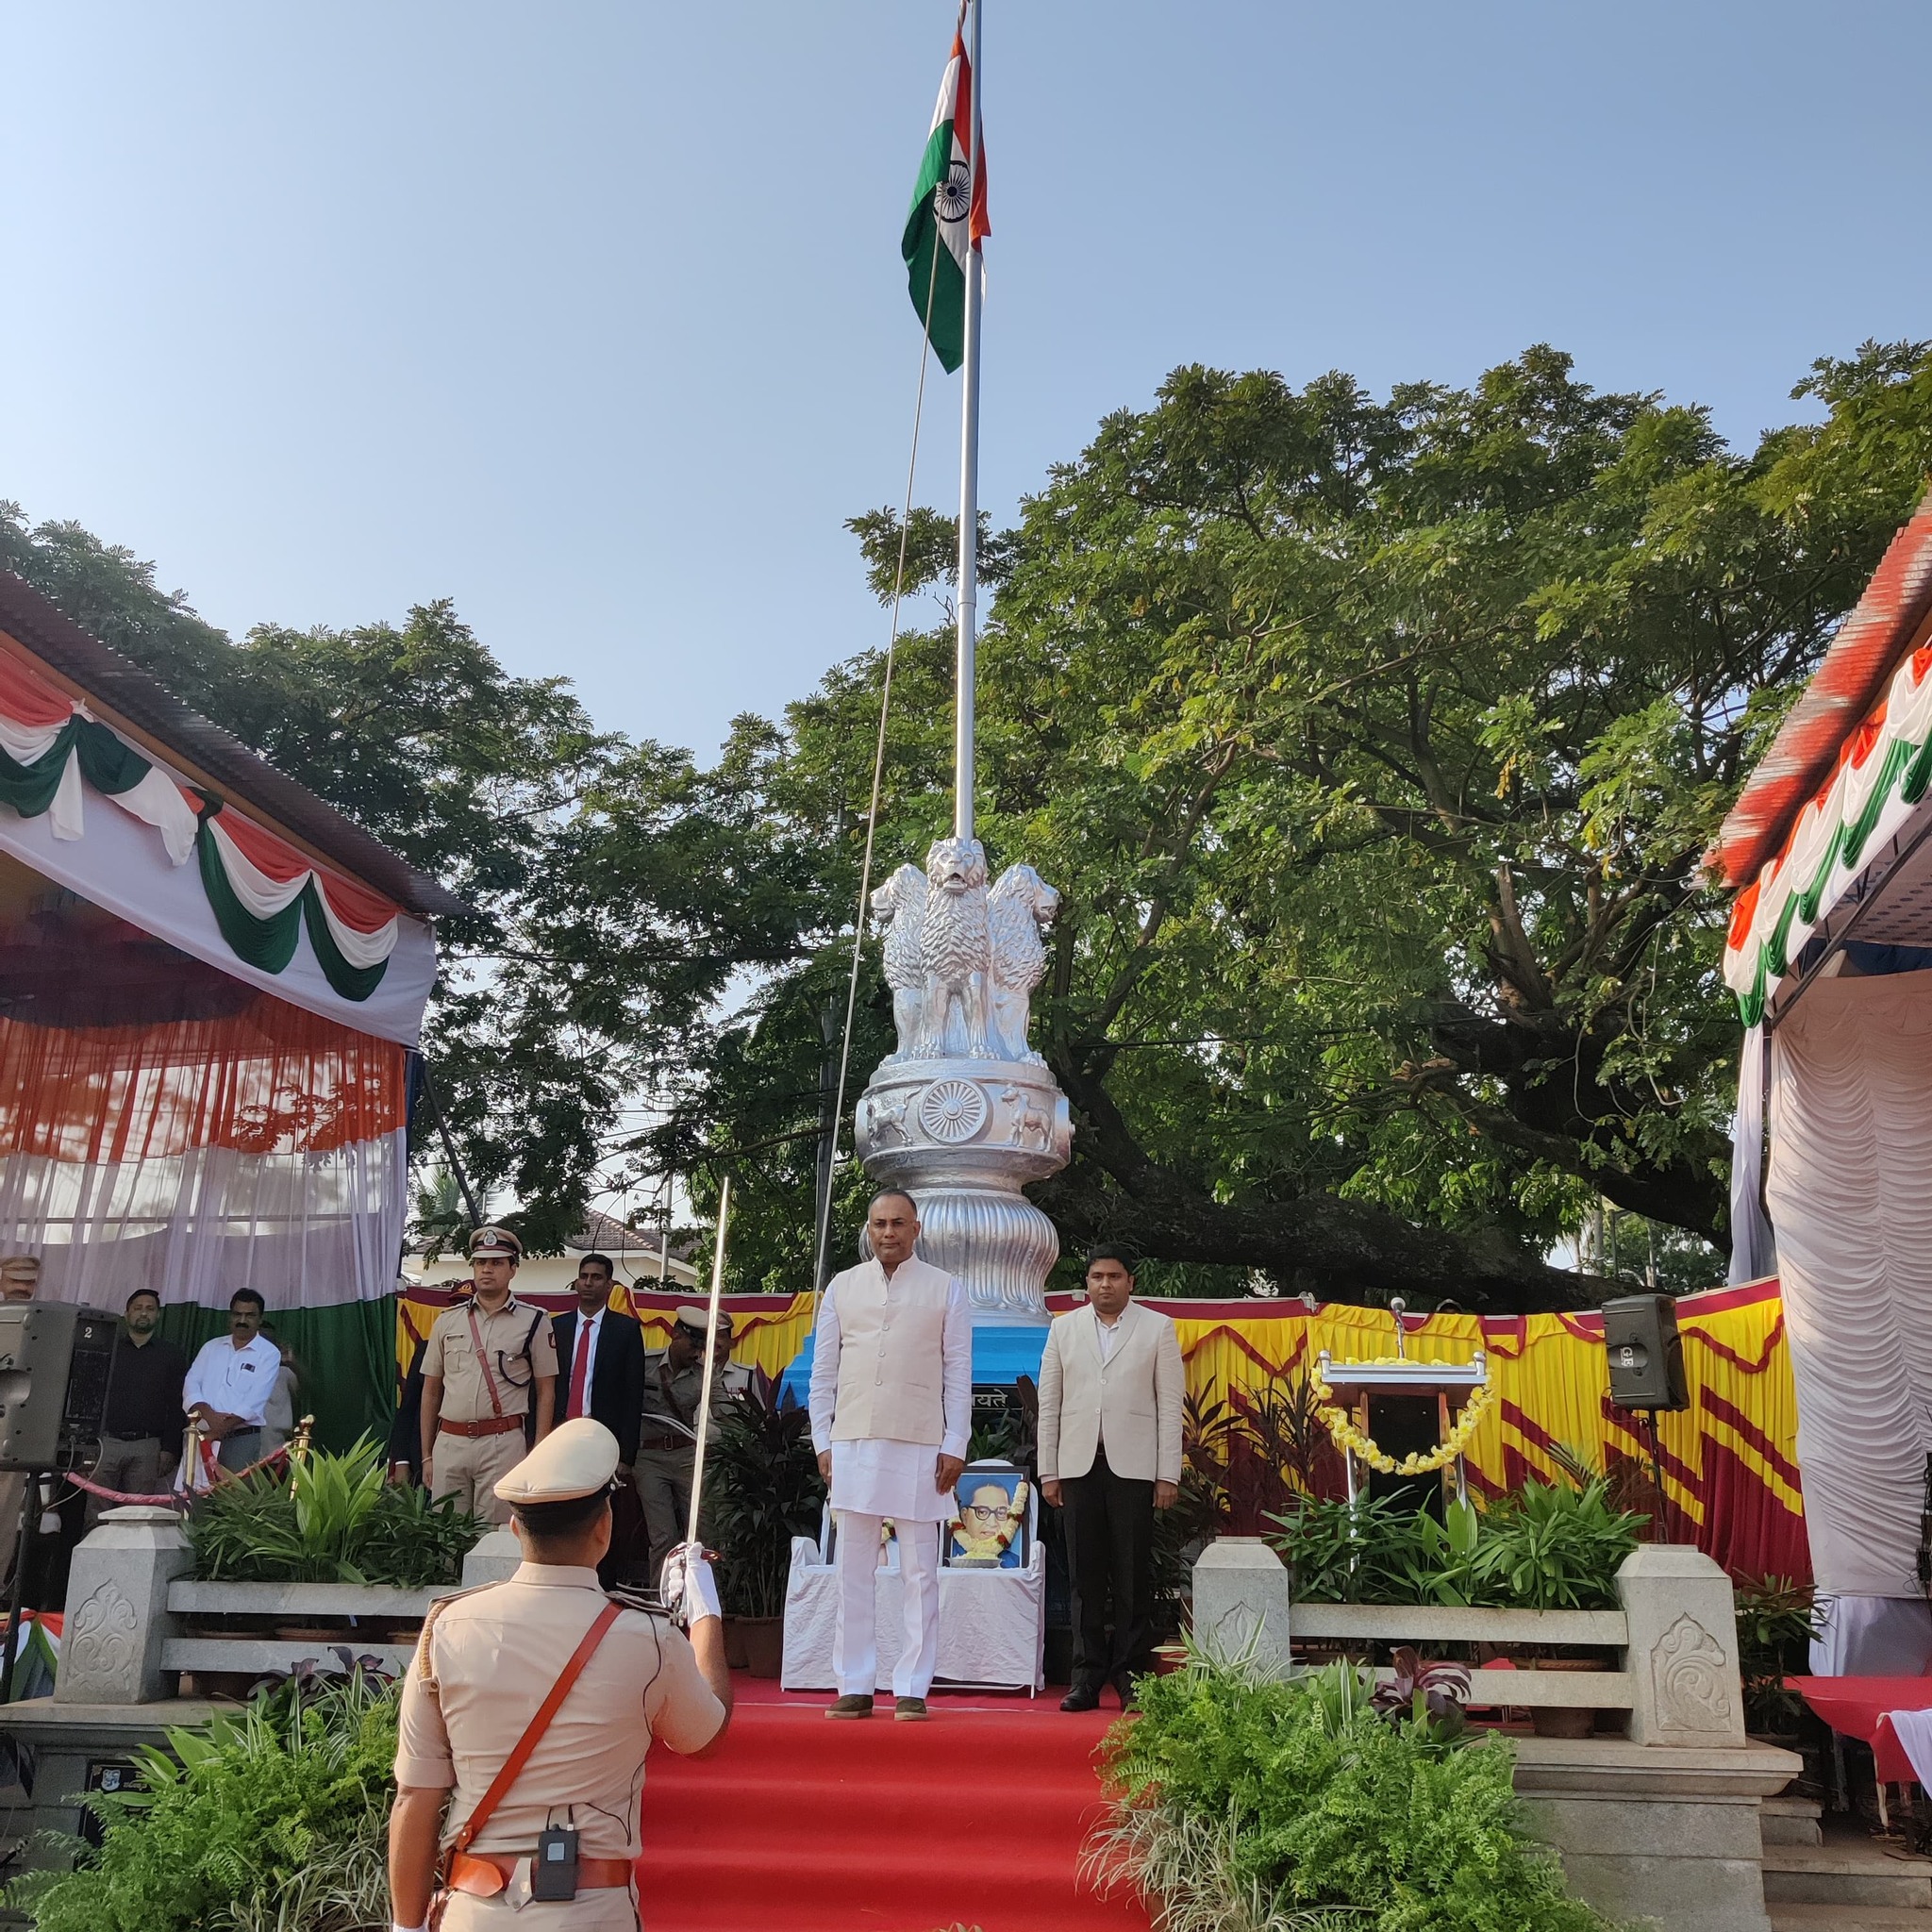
[856,839,1073,1322]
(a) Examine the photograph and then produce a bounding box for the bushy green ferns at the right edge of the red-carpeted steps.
[1093,1657,1604,1932]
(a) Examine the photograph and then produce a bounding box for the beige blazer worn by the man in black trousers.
[1040,1302,1186,1482]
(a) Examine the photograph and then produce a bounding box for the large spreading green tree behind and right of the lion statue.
[667,346,1932,1307]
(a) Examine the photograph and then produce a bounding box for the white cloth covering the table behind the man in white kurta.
[782,1536,1047,1690]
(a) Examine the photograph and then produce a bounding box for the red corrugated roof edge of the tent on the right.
[1706,491,1932,887]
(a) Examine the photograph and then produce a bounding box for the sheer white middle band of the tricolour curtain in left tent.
[0,1130,408,1310]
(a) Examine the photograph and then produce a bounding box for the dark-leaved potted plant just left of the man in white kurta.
[706,1374,824,1677]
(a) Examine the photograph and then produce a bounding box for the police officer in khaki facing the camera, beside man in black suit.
[424,1226,557,1523]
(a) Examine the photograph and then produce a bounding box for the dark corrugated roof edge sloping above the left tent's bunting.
[0,570,475,920]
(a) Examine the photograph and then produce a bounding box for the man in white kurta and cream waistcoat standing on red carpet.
[811,1191,972,1718]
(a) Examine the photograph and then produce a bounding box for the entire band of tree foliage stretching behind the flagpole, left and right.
[0,344,1932,1307]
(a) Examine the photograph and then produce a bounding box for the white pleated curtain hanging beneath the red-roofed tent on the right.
[1766,972,1932,1615]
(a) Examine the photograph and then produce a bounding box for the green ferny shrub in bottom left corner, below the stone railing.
[6,1672,398,1932]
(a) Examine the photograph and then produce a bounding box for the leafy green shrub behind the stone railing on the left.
[188,1436,489,1588]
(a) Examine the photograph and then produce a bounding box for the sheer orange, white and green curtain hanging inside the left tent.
[0,988,408,1438]
